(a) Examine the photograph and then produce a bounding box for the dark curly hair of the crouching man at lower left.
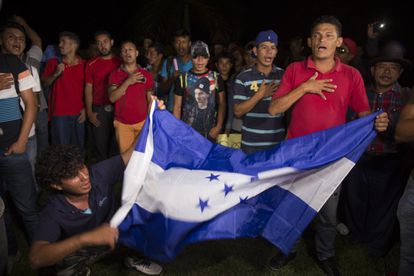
[36,145,84,189]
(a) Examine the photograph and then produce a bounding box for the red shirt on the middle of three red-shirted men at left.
[85,57,121,105]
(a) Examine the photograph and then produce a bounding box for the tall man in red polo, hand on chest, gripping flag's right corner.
[268,16,388,275]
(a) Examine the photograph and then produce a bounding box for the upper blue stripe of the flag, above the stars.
[136,104,378,175]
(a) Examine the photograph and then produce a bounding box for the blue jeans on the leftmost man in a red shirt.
[50,115,85,152]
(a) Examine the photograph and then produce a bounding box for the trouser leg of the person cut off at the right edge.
[397,175,414,276]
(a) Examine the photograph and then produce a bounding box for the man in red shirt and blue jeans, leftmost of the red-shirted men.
[41,31,85,151]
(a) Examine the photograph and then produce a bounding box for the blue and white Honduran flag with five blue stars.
[111,102,376,261]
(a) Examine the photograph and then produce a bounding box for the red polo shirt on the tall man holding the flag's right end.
[273,57,370,138]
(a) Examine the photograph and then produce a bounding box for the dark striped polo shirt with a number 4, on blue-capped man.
[233,66,286,153]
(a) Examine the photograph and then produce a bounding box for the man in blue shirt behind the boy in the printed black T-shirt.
[160,29,193,112]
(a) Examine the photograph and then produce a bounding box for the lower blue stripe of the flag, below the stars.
[119,183,316,262]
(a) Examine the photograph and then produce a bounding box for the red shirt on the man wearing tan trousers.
[109,68,154,125]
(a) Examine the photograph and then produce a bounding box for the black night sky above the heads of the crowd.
[0,0,414,59]
